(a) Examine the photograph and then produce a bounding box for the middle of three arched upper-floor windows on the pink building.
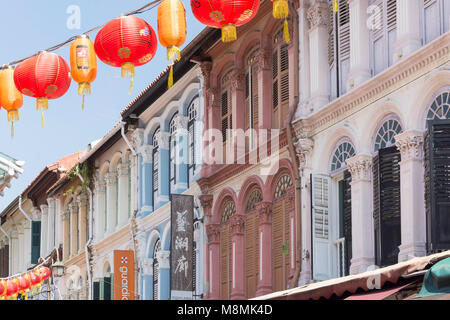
[245,49,258,150]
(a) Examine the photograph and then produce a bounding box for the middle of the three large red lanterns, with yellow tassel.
[94,16,158,93]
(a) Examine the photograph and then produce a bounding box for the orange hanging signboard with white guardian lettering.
[114,250,134,300]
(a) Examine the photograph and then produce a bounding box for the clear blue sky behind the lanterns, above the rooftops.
[0,0,204,212]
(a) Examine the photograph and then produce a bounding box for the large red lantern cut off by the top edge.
[191,0,260,42]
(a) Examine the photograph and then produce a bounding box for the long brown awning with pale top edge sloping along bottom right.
[254,251,450,300]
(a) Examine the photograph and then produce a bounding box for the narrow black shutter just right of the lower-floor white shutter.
[343,170,352,275]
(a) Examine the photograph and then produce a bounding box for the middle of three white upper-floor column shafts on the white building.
[347,0,372,90]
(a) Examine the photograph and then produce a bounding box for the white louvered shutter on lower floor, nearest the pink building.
[311,175,332,281]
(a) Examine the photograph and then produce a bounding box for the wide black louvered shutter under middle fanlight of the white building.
[374,147,401,267]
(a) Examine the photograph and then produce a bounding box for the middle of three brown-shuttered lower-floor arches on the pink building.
[245,186,263,299]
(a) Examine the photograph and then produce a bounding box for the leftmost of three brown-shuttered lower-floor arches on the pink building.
[220,197,236,300]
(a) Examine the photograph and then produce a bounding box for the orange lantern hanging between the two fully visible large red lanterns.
[70,35,97,109]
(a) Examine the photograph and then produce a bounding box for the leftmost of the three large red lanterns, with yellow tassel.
[14,52,71,126]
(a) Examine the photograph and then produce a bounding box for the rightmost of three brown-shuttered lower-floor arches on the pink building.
[272,173,293,292]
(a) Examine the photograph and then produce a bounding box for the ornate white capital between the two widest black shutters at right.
[395,130,424,161]
